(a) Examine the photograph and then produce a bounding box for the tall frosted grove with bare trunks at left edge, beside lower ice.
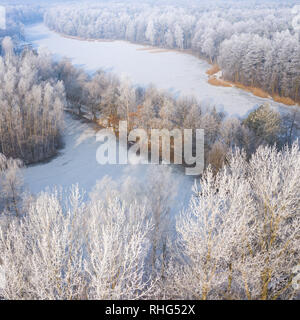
[0,38,65,163]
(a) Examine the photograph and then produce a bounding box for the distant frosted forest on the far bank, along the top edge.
[44,1,300,101]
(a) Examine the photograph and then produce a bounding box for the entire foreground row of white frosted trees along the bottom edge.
[0,143,300,300]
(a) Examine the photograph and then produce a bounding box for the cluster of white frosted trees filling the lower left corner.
[0,186,152,300]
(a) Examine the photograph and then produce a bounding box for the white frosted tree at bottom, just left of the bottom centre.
[84,198,152,299]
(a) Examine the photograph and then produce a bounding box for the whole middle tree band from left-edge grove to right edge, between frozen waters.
[0,33,299,170]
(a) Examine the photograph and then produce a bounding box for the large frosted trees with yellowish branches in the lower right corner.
[162,143,300,300]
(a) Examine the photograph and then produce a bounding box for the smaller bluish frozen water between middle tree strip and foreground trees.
[24,114,194,220]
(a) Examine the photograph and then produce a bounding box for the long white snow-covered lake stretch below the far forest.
[25,24,296,116]
